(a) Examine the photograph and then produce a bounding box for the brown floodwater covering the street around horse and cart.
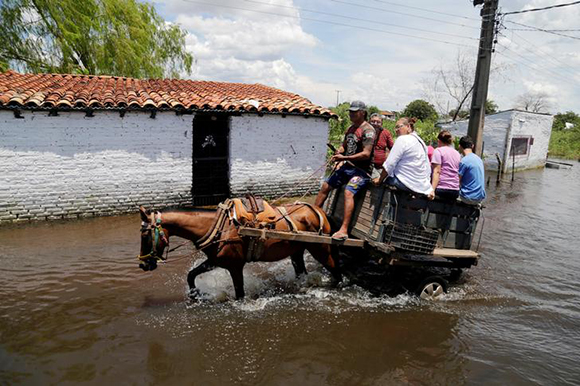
[0,163,580,385]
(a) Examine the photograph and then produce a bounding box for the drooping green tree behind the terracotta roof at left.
[0,0,193,78]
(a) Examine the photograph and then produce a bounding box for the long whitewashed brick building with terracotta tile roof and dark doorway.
[0,71,331,223]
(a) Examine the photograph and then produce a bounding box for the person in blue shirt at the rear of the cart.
[458,135,485,204]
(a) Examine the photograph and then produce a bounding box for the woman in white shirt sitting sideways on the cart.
[373,118,433,196]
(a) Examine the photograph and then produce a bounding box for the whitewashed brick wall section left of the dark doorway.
[0,110,193,222]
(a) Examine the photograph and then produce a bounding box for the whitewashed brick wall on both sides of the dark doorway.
[0,110,328,223]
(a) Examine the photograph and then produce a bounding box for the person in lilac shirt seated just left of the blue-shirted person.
[431,130,461,201]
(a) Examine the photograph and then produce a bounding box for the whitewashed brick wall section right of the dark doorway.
[230,115,328,198]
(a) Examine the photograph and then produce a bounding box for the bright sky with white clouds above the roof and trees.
[154,0,580,113]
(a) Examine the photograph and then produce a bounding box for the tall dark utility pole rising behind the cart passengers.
[467,0,499,156]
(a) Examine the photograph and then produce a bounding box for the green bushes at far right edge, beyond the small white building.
[549,111,580,159]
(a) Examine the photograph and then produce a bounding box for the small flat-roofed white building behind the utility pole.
[441,110,554,172]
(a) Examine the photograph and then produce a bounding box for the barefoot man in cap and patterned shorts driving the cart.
[315,101,376,240]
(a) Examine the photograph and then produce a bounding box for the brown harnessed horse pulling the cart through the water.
[139,203,342,299]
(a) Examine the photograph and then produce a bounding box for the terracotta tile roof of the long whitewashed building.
[0,71,334,117]
